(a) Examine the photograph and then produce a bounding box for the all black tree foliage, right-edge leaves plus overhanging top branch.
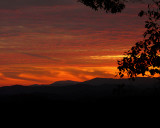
[78,0,160,78]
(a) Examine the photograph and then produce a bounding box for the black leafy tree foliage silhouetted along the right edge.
[118,1,160,78]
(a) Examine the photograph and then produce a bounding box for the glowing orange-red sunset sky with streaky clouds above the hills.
[0,0,146,86]
